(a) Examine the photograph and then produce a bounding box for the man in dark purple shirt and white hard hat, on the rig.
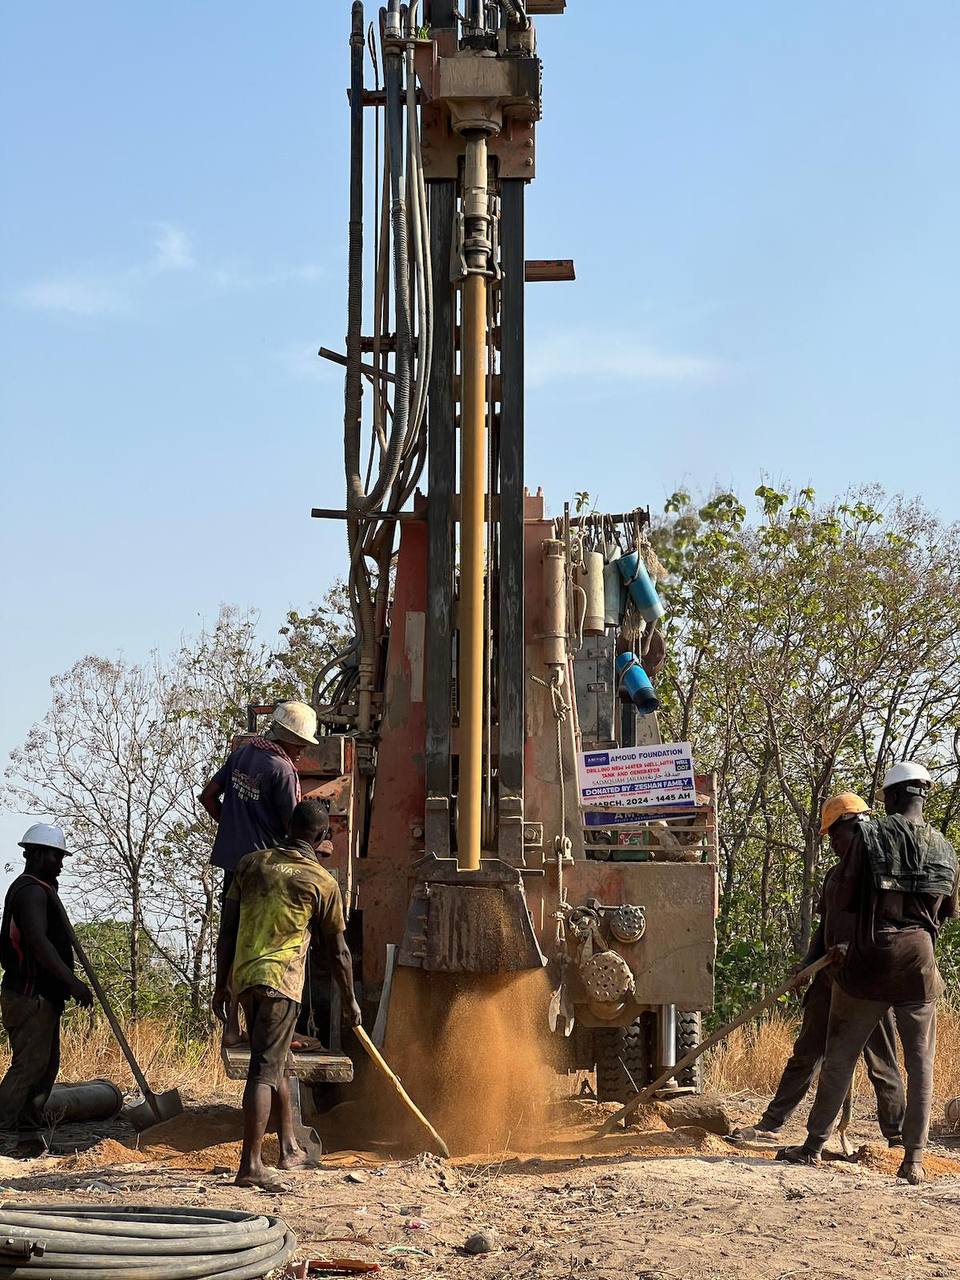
[200,701,316,1044]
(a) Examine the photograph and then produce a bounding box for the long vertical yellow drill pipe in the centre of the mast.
[457,266,486,872]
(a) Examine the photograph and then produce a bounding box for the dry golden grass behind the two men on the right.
[705,1005,960,1101]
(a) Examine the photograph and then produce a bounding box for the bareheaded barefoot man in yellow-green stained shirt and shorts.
[214,800,361,1190]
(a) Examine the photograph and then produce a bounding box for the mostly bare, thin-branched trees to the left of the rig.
[4,584,355,1027]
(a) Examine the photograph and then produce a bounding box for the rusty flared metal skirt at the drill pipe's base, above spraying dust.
[398,854,547,974]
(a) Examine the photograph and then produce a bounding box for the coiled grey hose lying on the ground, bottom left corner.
[0,1203,297,1280]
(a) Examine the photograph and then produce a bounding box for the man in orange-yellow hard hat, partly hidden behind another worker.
[731,791,905,1147]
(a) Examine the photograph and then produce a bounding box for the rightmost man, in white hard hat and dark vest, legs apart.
[777,760,957,1185]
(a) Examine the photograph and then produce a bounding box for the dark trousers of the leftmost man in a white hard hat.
[0,991,63,1133]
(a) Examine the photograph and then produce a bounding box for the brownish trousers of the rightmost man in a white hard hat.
[806,986,937,1160]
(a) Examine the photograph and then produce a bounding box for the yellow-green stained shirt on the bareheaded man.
[227,842,344,1001]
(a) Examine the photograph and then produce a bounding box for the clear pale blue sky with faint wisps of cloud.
[0,0,960,860]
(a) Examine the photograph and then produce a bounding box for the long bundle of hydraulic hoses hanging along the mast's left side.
[330,0,434,735]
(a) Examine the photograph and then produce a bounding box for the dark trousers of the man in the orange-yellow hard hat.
[756,972,905,1139]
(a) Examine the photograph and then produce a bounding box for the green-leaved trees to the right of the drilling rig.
[654,485,960,1002]
